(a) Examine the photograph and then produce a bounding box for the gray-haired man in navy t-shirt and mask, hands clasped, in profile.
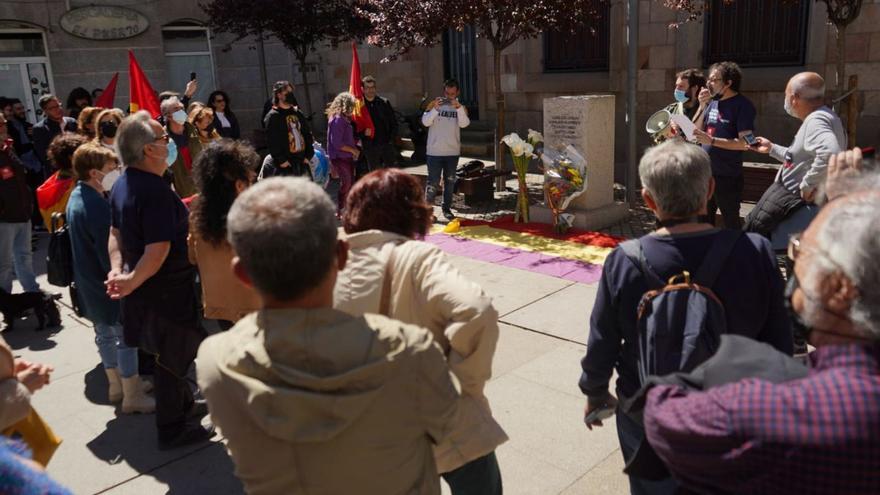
[105,111,213,449]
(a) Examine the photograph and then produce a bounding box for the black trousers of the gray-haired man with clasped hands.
[122,285,206,440]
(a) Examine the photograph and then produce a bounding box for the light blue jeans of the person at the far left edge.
[0,221,40,293]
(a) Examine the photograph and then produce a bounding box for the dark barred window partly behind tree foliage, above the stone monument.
[544,2,611,72]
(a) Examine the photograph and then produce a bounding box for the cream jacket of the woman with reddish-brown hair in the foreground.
[334,230,507,473]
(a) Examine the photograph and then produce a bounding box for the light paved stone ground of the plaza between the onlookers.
[4,161,651,495]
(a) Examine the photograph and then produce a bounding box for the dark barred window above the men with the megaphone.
[703,0,811,67]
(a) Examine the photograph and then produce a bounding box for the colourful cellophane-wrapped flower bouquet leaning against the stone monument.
[541,145,587,233]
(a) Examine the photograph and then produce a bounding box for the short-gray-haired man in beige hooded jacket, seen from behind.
[197,178,458,495]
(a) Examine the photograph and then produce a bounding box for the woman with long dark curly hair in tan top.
[187,139,260,330]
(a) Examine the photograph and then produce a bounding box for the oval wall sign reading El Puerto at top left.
[61,6,150,41]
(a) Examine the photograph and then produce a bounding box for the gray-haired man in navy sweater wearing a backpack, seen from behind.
[580,140,792,494]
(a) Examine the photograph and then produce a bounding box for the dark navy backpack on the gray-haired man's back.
[621,230,742,383]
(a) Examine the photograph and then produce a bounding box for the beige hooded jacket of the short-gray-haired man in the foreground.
[197,309,458,495]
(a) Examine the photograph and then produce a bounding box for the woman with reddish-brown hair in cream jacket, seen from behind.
[334,169,507,495]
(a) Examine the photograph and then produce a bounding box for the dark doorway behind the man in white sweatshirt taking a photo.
[443,26,480,120]
